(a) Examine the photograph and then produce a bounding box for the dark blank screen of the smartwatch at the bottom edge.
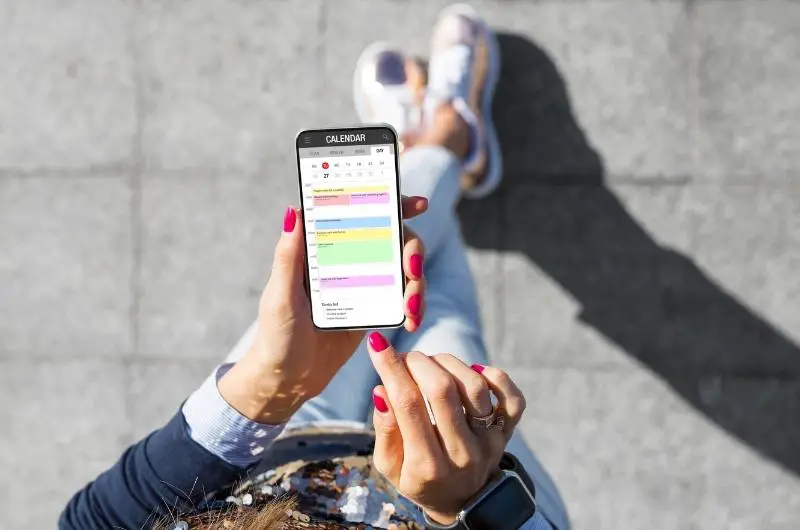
[465,477,536,530]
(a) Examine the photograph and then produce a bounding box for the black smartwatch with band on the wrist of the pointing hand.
[425,453,536,530]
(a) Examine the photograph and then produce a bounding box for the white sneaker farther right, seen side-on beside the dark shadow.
[425,4,503,199]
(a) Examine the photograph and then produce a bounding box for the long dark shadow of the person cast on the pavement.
[459,35,800,474]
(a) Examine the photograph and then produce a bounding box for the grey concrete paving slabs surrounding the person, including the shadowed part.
[0,0,800,530]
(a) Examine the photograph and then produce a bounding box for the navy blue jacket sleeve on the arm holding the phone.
[58,412,246,530]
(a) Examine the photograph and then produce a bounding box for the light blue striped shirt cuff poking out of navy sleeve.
[182,364,284,468]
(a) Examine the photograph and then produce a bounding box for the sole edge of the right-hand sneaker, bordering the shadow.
[440,4,503,199]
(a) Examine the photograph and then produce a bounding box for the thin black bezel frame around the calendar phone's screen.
[294,123,408,331]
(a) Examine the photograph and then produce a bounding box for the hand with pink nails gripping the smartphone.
[217,197,428,424]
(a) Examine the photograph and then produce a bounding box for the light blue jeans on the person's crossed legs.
[228,146,569,530]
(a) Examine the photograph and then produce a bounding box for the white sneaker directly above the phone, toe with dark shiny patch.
[353,42,425,138]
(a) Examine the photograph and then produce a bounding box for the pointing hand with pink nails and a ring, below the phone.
[368,332,525,525]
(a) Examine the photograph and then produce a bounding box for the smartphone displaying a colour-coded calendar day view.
[296,125,405,330]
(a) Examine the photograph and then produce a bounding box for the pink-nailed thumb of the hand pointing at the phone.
[372,385,403,486]
